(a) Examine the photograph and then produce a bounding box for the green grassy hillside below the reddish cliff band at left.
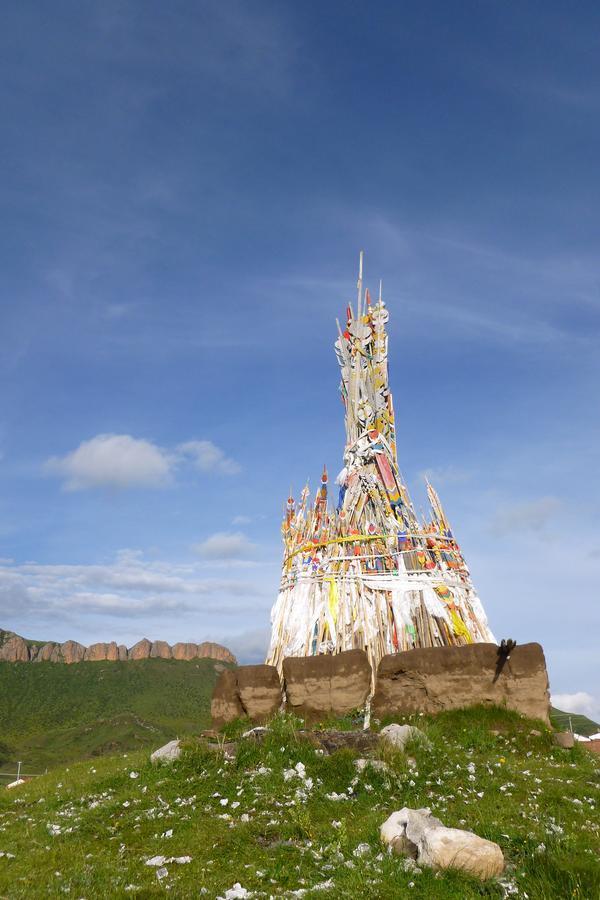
[0,659,230,783]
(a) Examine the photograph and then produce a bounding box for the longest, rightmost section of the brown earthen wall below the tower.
[372,644,550,724]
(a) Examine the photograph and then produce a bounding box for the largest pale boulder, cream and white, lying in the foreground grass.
[380,807,504,878]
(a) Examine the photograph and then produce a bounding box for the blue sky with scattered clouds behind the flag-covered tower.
[0,0,600,714]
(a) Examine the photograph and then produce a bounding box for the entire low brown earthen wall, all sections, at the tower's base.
[211,643,550,728]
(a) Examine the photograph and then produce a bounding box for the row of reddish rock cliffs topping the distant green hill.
[0,629,237,665]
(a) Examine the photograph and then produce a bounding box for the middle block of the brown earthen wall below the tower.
[283,650,371,721]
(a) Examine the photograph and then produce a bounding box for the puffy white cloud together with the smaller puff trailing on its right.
[44,434,240,491]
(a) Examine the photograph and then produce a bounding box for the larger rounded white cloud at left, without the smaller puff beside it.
[45,434,172,491]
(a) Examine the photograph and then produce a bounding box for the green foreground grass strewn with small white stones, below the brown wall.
[0,708,600,900]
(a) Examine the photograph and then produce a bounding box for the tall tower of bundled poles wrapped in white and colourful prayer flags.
[267,253,495,672]
